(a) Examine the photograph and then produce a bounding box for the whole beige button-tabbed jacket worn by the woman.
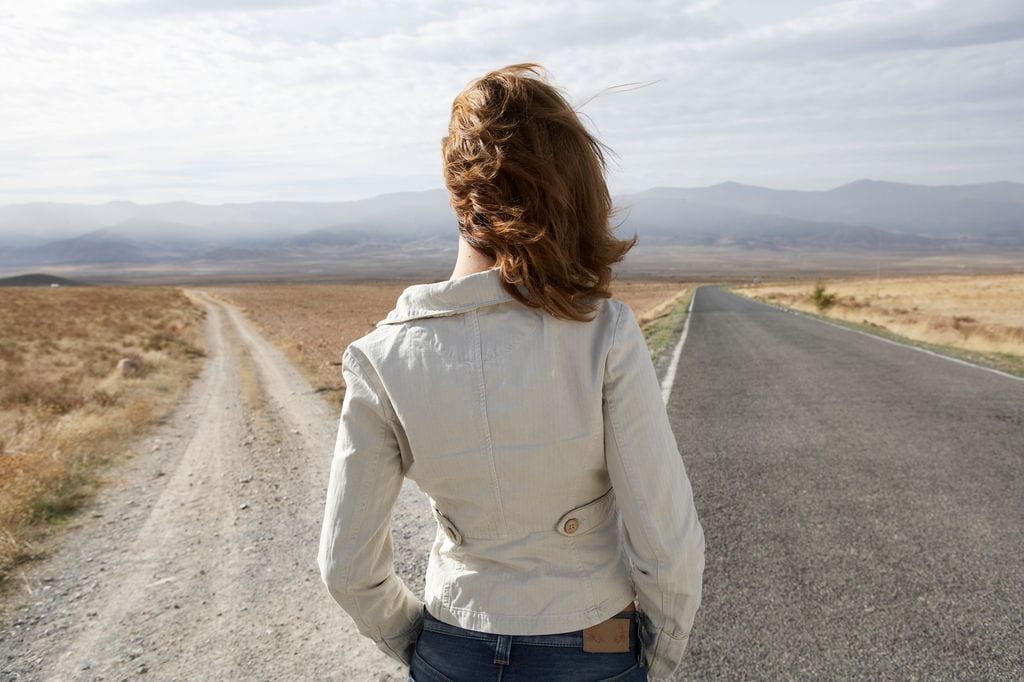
[318,269,705,679]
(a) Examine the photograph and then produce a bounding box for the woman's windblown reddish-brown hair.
[441,63,636,322]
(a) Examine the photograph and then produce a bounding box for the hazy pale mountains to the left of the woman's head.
[0,189,456,265]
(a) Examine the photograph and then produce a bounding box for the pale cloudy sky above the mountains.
[0,0,1024,204]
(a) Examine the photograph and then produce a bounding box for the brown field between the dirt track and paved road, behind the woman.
[203,280,686,407]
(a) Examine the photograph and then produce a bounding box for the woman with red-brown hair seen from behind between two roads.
[319,65,703,682]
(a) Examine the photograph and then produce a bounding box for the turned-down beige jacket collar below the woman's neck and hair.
[377,268,514,327]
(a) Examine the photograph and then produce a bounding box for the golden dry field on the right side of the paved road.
[734,274,1024,369]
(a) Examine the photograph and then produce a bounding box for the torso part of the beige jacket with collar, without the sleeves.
[350,270,634,634]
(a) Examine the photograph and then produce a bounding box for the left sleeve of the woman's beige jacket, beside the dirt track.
[318,347,423,666]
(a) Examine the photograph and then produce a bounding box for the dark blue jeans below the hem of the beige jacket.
[409,608,647,682]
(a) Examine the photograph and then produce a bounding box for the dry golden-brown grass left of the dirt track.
[0,287,203,576]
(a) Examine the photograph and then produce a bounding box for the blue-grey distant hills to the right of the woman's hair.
[622,180,1024,245]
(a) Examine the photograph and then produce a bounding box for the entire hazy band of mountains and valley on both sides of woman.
[0,180,1024,281]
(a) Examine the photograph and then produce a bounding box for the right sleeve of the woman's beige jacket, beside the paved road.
[604,304,705,680]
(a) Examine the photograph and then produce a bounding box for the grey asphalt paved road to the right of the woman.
[669,288,1024,680]
